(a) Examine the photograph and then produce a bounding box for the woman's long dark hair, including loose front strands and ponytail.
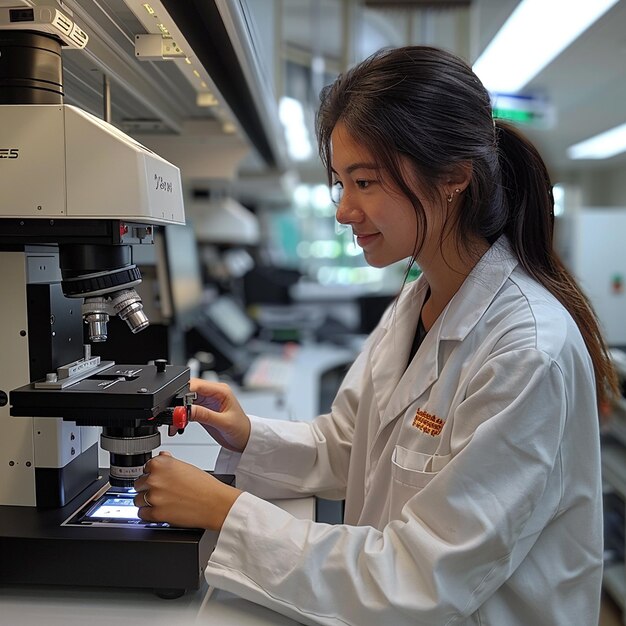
[316,46,618,401]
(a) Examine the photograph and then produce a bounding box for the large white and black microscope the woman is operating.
[0,6,215,597]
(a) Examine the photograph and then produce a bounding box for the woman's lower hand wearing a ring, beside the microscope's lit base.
[134,452,241,531]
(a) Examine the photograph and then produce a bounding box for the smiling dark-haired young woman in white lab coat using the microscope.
[135,47,615,626]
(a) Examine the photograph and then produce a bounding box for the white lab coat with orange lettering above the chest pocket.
[206,238,602,626]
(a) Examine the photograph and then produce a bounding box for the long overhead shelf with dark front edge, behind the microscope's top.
[42,0,289,178]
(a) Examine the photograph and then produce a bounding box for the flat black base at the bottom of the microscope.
[0,480,217,597]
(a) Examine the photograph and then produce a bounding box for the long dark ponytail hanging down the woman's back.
[496,120,619,403]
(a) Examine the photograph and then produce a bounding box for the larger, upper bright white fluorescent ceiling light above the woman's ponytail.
[473,0,618,93]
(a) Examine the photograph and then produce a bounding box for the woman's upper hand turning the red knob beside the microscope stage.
[170,378,250,452]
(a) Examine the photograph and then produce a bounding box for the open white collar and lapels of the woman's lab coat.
[372,236,518,432]
